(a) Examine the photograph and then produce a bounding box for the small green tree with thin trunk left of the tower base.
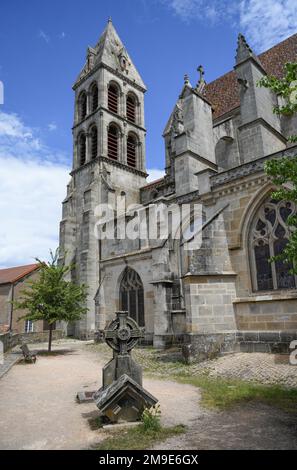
[13,250,88,352]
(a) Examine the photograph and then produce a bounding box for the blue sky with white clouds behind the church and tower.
[0,0,297,267]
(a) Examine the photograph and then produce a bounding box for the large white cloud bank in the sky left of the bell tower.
[0,112,69,267]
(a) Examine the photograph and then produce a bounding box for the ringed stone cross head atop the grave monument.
[103,312,144,355]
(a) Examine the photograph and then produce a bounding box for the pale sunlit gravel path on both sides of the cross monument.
[0,342,199,449]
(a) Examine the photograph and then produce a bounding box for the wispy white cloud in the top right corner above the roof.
[161,0,297,53]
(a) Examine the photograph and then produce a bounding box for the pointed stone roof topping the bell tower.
[74,19,146,90]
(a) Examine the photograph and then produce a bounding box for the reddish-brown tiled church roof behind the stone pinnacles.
[205,34,297,119]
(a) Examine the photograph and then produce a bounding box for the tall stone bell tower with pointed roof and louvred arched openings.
[60,20,147,338]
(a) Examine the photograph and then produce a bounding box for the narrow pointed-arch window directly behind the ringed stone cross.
[120,268,144,326]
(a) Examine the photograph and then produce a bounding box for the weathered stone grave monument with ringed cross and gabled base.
[94,312,158,423]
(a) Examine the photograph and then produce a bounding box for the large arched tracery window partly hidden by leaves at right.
[249,199,297,291]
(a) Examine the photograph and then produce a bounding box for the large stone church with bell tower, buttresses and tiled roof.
[60,17,297,354]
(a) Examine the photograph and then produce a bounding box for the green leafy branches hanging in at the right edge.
[258,63,297,274]
